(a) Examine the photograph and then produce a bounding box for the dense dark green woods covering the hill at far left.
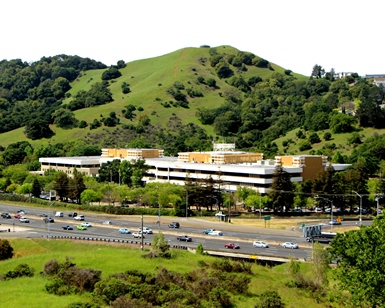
[0,55,106,135]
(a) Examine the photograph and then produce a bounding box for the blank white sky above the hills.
[0,0,385,76]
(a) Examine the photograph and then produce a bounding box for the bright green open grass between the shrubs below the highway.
[0,239,339,308]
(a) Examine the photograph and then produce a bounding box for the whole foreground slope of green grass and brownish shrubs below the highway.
[0,239,339,308]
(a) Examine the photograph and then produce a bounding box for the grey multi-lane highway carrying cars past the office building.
[0,204,348,260]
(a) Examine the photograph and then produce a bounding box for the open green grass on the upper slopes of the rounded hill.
[0,46,307,147]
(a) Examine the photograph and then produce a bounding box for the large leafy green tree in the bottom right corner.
[329,215,385,307]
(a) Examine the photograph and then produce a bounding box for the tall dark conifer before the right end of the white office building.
[269,166,294,212]
